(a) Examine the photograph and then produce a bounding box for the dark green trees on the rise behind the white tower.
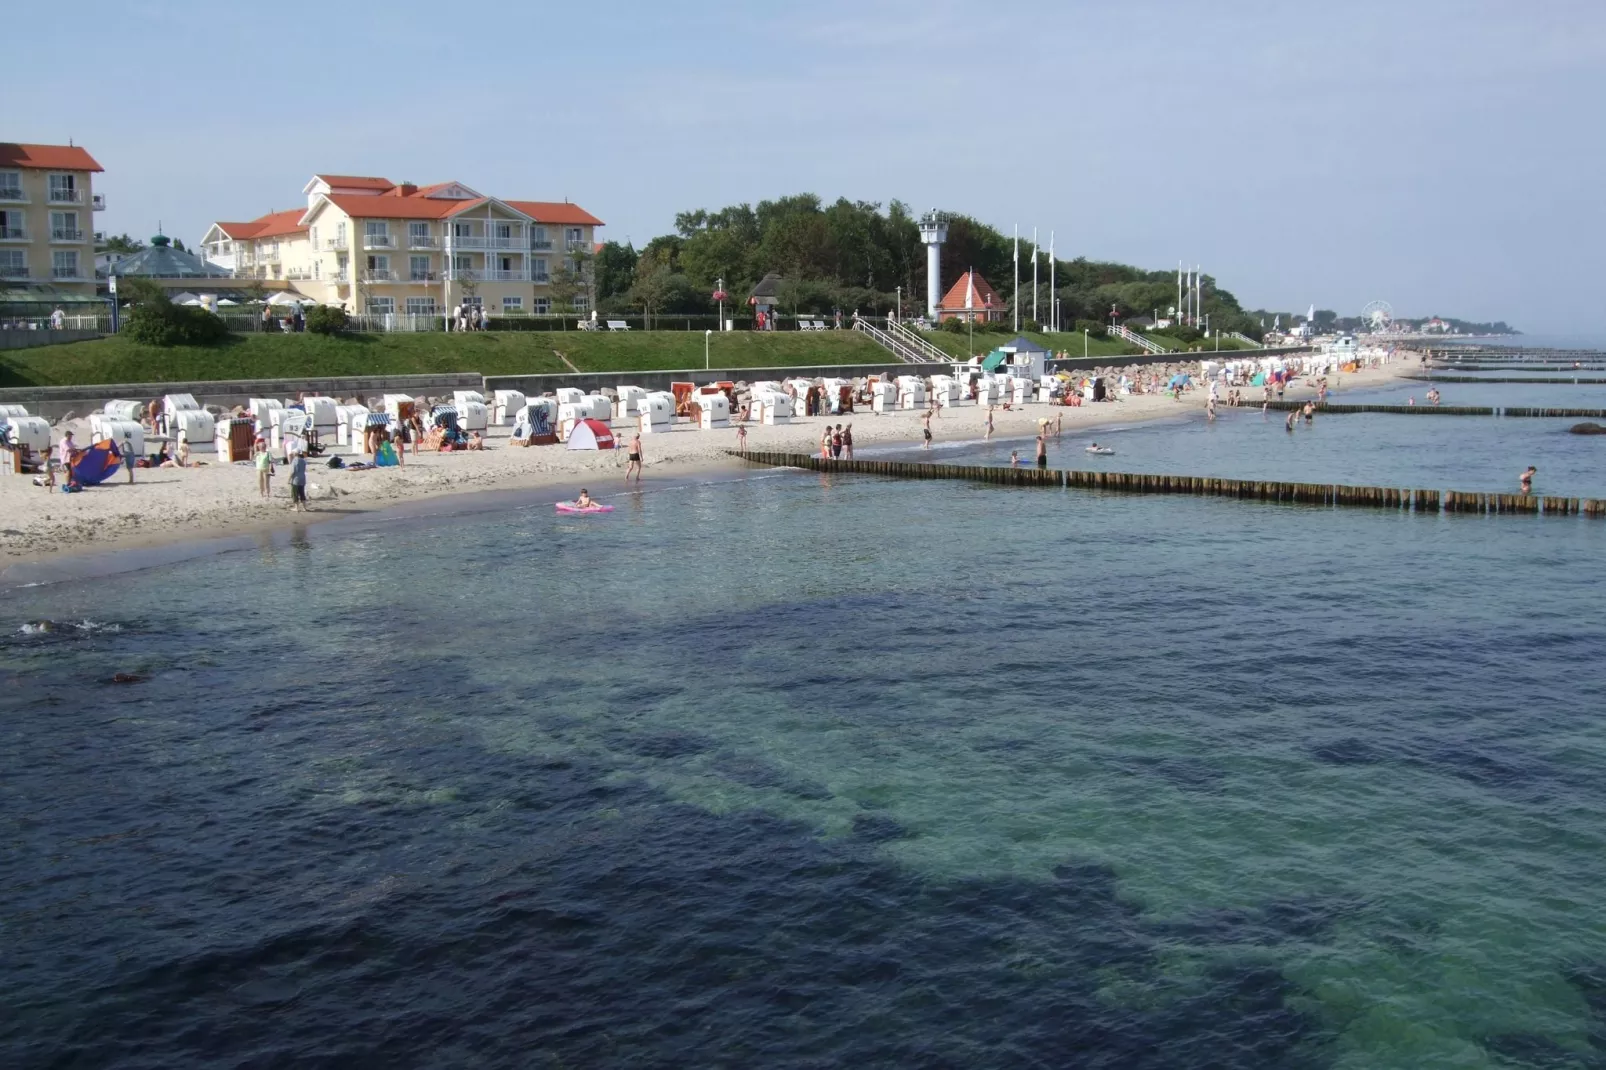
[584,193,1261,337]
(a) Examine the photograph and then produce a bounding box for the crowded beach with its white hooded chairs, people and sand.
[0,348,1402,561]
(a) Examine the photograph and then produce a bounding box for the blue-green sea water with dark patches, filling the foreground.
[0,387,1606,1070]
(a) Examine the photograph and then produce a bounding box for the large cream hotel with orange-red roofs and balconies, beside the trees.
[201,175,602,315]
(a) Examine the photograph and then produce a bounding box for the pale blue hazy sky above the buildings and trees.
[12,0,1606,333]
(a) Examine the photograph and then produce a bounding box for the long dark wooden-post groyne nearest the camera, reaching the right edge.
[729,450,1606,519]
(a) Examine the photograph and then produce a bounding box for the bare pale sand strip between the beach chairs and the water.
[0,361,1408,567]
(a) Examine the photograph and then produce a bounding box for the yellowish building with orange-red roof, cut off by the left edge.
[0,143,106,300]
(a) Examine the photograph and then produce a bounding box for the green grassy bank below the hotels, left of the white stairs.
[0,331,891,387]
